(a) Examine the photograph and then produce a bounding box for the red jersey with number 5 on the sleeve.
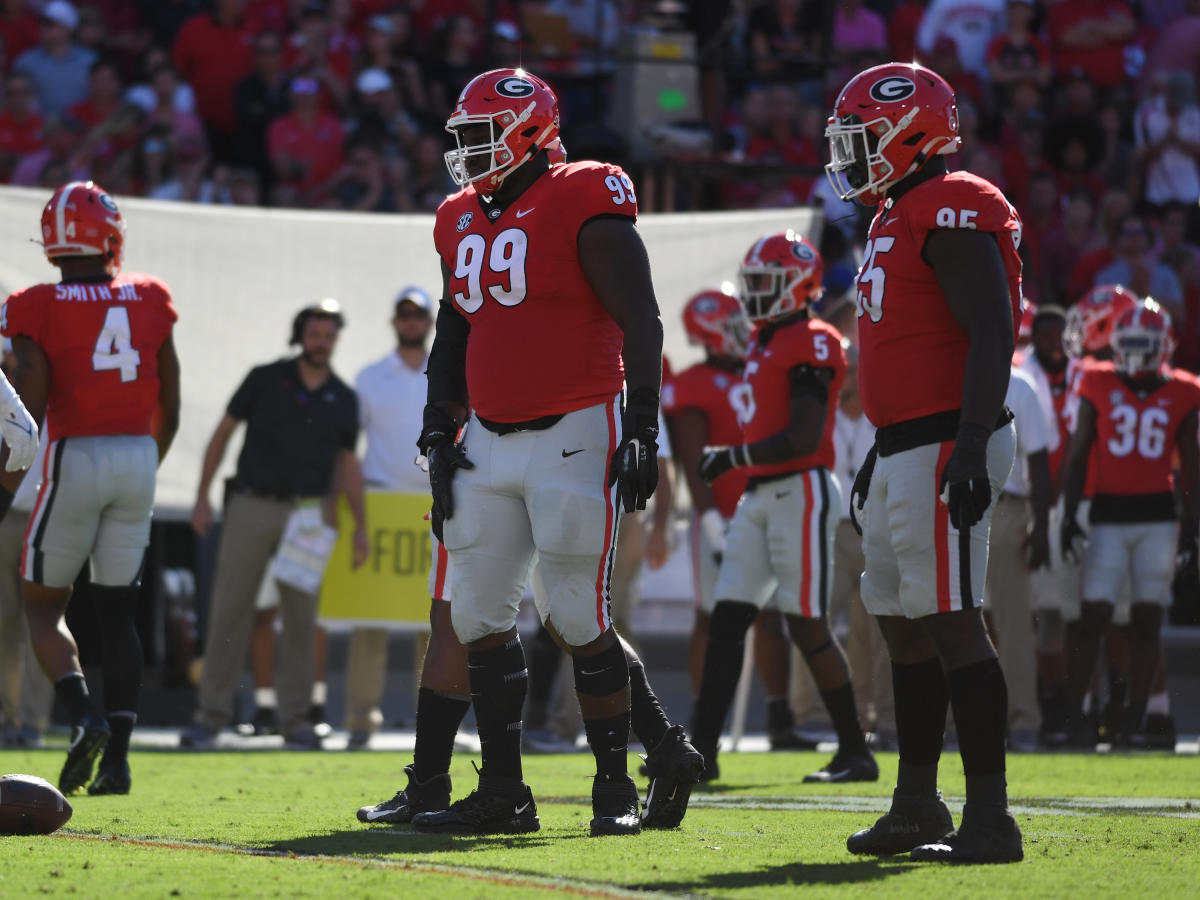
[734,319,846,475]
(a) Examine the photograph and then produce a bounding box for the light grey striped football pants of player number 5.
[715,468,841,619]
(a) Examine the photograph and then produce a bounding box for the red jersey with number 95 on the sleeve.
[858,172,1021,427]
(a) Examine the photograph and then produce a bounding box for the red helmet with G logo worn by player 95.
[826,62,959,203]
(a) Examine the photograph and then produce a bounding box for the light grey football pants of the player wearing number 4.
[20,434,158,588]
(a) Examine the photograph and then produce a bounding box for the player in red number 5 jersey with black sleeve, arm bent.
[692,230,880,782]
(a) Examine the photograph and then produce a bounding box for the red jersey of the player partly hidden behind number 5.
[662,362,749,518]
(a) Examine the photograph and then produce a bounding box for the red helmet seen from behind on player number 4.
[42,181,125,272]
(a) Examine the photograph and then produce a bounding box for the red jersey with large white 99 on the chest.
[433,162,637,422]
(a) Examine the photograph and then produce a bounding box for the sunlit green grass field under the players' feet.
[0,750,1200,900]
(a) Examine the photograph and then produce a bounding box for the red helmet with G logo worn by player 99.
[445,68,558,197]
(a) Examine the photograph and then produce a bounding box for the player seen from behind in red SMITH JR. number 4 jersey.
[0,181,179,793]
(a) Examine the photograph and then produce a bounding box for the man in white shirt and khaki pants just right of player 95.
[984,366,1052,750]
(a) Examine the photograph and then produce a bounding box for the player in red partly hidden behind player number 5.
[662,289,816,750]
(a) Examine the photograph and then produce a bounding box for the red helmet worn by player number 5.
[738,228,824,322]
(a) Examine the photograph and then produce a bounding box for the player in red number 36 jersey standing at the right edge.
[1062,300,1200,746]
